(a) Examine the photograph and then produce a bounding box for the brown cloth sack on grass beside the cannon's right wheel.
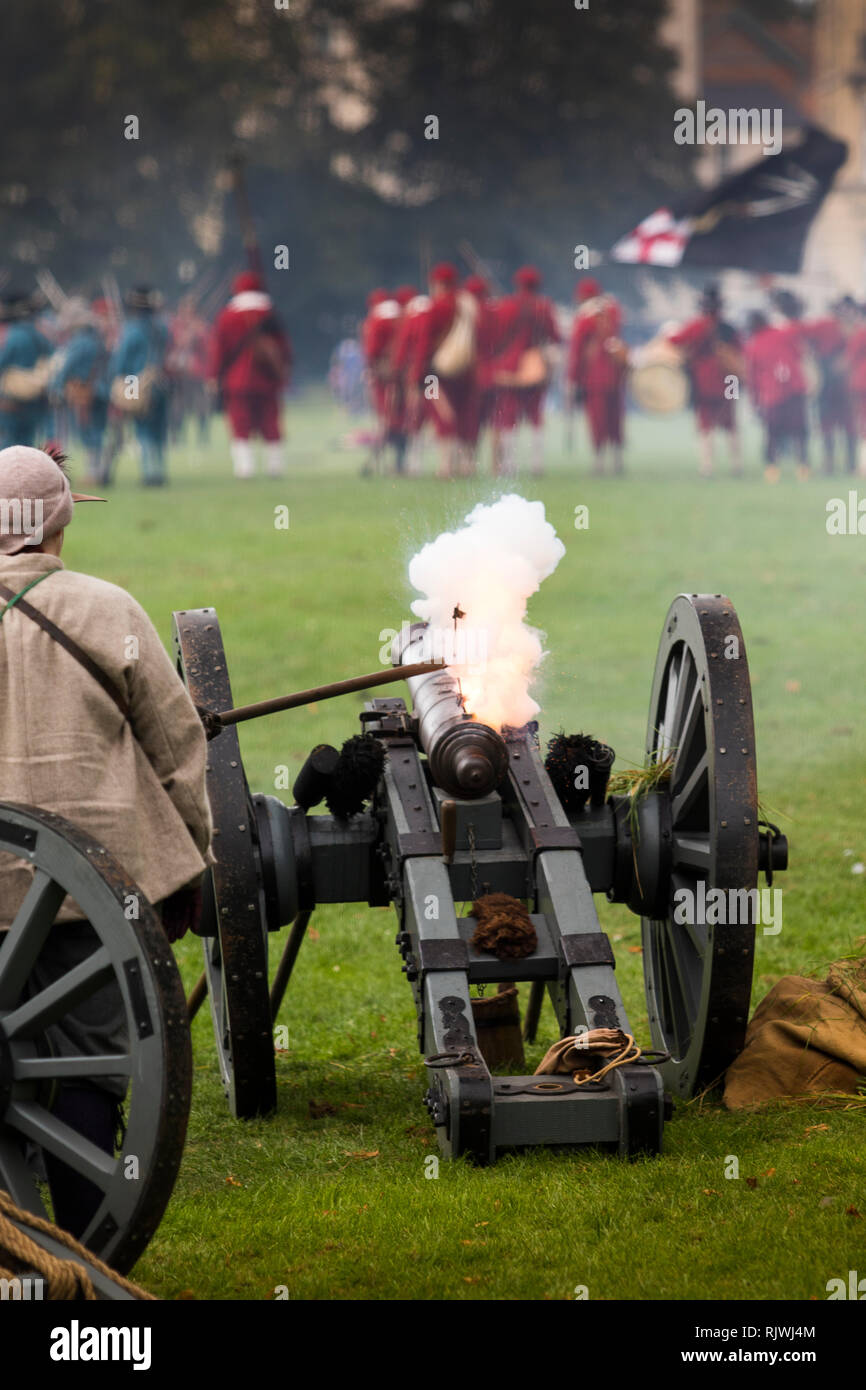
[724,956,866,1111]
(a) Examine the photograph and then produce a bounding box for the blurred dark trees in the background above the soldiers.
[0,0,700,367]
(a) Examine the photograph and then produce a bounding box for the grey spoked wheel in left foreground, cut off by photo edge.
[0,802,192,1273]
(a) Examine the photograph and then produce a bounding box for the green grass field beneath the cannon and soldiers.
[64,398,866,1300]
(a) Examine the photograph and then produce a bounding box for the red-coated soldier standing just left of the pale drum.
[566,275,628,474]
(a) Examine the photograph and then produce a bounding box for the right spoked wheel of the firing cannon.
[642,594,759,1095]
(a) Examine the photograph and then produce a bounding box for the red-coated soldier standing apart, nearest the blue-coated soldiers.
[209,271,292,478]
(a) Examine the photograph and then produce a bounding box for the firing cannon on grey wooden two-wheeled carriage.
[172,594,787,1163]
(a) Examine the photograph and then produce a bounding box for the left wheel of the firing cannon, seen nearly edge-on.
[172,609,277,1119]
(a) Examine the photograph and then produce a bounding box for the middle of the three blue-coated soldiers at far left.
[53,297,111,488]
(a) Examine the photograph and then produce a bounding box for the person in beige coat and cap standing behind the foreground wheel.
[0,445,213,1230]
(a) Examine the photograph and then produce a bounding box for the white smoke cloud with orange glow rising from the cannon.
[409,492,566,728]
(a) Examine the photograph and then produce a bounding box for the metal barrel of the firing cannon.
[392,623,509,801]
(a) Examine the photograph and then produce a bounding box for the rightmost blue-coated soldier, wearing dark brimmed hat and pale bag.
[108,286,168,488]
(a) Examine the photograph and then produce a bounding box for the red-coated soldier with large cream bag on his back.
[409,261,478,478]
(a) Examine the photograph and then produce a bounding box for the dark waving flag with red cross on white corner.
[610,126,848,274]
